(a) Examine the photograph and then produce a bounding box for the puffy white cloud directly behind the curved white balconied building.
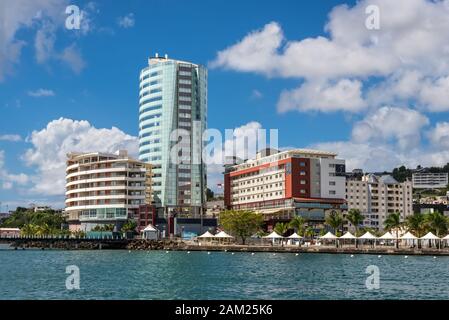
[22,118,138,195]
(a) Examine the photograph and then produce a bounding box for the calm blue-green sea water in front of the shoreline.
[0,250,449,300]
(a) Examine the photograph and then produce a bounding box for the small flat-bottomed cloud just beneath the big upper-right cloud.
[277,79,366,112]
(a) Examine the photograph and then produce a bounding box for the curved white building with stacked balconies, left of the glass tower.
[65,151,151,231]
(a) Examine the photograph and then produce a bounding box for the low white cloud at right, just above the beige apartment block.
[310,107,449,172]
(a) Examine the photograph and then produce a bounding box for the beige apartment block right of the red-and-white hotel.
[346,174,413,230]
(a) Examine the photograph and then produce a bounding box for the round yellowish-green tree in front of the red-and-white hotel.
[220,210,263,244]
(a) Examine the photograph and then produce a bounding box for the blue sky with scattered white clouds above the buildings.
[0,0,449,211]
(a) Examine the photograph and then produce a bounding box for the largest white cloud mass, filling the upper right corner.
[210,0,449,112]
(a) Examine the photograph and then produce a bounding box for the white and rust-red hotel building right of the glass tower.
[224,149,346,226]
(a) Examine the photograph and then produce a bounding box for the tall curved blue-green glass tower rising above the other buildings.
[139,54,207,216]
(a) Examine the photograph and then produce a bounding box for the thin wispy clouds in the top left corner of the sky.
[0,0,94,81]
